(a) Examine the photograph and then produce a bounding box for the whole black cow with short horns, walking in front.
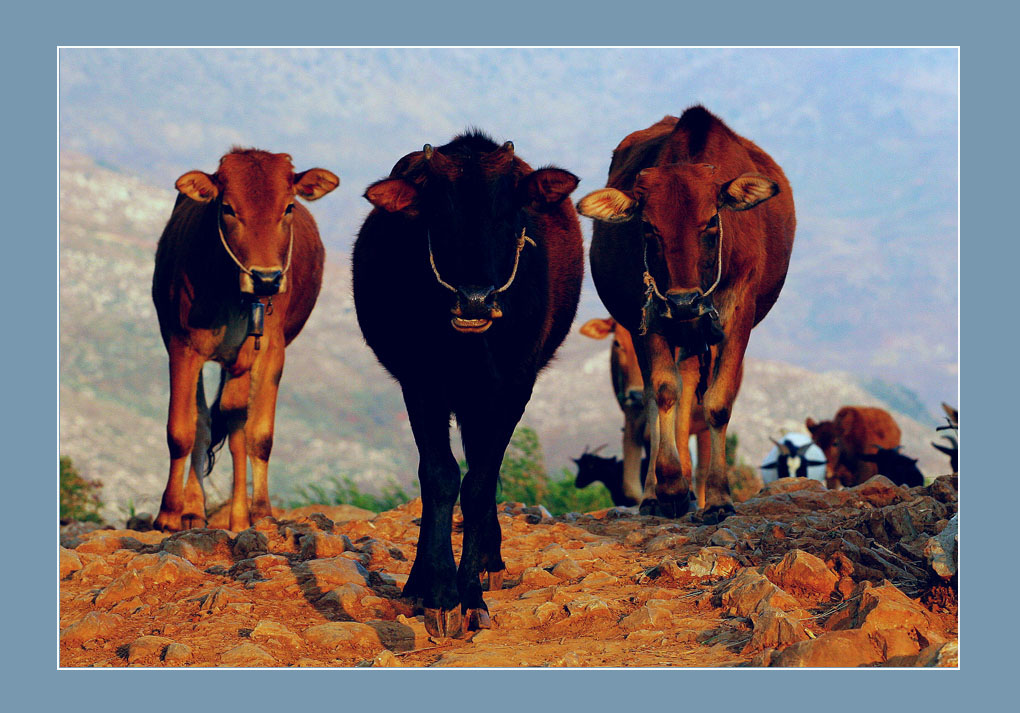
[352,131,584,636]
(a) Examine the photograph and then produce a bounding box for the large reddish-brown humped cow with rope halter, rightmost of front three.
[578,105,797,523]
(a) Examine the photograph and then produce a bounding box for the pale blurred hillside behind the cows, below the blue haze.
[59,152,946,517]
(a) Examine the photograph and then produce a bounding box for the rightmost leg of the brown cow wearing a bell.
[245,337,284,521]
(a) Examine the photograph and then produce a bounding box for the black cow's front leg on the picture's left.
[404,387,462,636]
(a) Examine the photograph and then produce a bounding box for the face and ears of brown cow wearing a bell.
[176,150,340,296]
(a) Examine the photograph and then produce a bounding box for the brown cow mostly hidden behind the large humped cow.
[578,317,744,508]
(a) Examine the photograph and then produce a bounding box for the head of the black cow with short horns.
[365,135,577,334]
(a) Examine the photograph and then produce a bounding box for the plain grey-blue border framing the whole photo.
[17,0,1003,710]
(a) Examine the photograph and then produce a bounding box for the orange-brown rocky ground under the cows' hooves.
[59,476,958,667]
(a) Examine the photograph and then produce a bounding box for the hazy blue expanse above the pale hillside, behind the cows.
[59,48,959,412]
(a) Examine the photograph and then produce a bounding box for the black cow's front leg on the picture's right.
[457,387,531,630]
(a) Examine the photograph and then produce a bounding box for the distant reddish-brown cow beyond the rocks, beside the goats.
[804,406,901,490]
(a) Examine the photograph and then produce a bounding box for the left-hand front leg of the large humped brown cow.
[634,334,691,517]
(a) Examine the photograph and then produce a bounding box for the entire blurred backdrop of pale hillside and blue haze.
[59,48,959,517]
